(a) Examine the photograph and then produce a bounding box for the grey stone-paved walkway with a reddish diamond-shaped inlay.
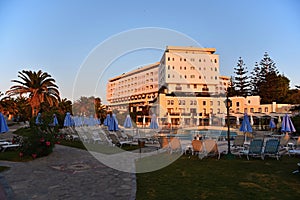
[0,145,136,200]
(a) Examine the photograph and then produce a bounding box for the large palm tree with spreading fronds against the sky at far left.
[6,70,60,116]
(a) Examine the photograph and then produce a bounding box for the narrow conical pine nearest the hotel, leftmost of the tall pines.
[234,57,250,97]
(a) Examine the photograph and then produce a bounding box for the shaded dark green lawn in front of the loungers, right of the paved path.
[136,156,300,200]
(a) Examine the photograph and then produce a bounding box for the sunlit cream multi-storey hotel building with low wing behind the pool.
[106,46,288,125]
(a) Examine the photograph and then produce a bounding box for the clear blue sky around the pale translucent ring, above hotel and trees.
[0,0,300,103]
